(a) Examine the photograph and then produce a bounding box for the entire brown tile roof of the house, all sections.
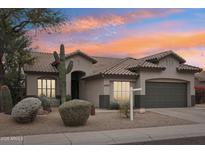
[24,51,201,78]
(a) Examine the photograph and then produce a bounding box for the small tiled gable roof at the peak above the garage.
[142,50,186,63]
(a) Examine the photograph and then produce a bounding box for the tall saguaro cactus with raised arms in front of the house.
[53,44,73,104]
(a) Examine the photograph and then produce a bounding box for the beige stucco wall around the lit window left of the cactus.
[26,73,60,96]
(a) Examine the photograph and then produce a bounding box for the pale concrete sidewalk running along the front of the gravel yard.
[0,124,205,145]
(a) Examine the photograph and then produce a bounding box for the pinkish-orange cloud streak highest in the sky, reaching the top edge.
[61,9,182,33]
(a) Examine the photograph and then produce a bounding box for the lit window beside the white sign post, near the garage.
[113,82,130,103]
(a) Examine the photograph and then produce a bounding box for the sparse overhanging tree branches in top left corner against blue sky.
[0,8,66,82]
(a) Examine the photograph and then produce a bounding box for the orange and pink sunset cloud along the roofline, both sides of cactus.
[32,31,205,67]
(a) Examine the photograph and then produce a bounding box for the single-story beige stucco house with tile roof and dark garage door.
[24,51,202,108]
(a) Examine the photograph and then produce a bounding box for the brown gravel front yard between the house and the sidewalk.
[0,108,194,136]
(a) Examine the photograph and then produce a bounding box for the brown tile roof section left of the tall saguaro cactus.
[24,52,58,73]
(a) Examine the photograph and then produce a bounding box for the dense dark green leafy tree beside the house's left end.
[4,36,36,104]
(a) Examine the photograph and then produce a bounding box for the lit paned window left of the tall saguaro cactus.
[38,79,56,97]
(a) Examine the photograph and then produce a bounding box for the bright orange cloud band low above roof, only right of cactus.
[60,32,205,57]
